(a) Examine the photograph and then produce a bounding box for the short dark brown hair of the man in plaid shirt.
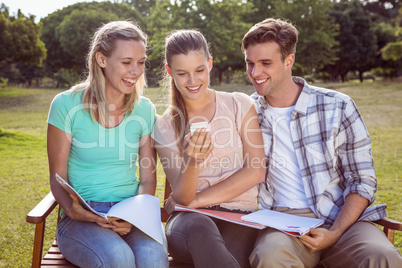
[241,18,299,61]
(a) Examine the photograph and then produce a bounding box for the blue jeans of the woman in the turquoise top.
[57,201,169,268]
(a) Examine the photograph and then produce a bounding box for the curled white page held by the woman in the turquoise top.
[107,194,163,244]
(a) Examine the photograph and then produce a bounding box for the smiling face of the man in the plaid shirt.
[244,42,294,100]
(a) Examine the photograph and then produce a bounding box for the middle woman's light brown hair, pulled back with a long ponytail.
[165,29,212,152]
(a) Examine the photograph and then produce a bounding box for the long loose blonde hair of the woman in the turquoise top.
[71,21,147,125]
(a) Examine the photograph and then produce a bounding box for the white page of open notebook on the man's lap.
[242,209,324,233]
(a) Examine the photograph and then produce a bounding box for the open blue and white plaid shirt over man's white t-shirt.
[251,77,386,224]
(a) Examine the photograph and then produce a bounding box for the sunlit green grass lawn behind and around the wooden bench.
[0,82,402,267]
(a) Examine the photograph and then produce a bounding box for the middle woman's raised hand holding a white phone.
[183,129,214,165]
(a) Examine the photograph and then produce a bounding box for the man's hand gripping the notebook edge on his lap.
[299,228,340,252]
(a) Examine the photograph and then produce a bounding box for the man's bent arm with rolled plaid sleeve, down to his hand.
[300,100,377,252]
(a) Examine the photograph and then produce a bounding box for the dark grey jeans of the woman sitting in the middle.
[166,212,258,268]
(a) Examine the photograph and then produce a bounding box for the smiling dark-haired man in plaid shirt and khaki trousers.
[242,19,402,267]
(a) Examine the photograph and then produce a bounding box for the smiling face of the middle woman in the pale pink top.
[166,51,212,101]
